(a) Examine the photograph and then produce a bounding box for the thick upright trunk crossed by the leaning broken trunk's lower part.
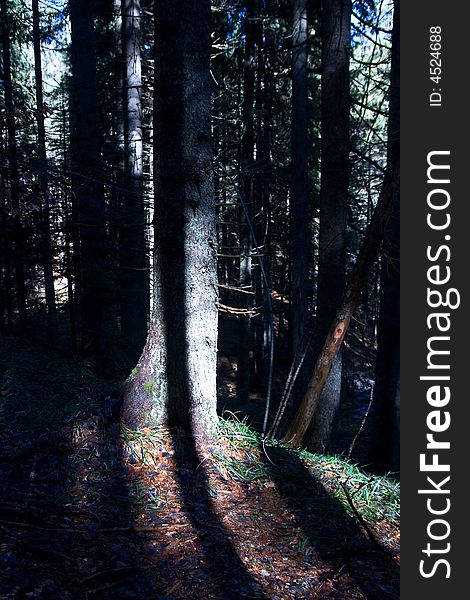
[309,0,351,450]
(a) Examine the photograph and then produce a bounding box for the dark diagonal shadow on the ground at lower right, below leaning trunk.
[262,447,399,600]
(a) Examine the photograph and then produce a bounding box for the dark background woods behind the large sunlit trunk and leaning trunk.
[0,0,399,469]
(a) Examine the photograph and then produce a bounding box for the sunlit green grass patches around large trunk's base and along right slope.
[122,413,400,526]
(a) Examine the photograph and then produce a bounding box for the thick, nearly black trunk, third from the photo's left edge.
[70,0,107,364]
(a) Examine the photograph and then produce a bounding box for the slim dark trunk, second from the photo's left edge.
[32,0,57,344]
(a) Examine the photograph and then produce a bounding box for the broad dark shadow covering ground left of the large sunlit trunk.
[0,340,158,600]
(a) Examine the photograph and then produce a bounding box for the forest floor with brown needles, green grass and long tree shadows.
[0,338,399,600]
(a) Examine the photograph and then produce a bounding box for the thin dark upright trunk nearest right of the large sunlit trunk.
[237,0,255,402]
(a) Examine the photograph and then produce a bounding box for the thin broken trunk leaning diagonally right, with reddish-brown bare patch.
[283,165,399,448]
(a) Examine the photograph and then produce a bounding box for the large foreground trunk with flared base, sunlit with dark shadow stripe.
[122,0,217,434]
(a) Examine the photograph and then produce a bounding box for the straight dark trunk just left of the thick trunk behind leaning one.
[290,0,311,356]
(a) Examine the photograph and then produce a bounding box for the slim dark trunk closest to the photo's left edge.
[0,0,27,334]
